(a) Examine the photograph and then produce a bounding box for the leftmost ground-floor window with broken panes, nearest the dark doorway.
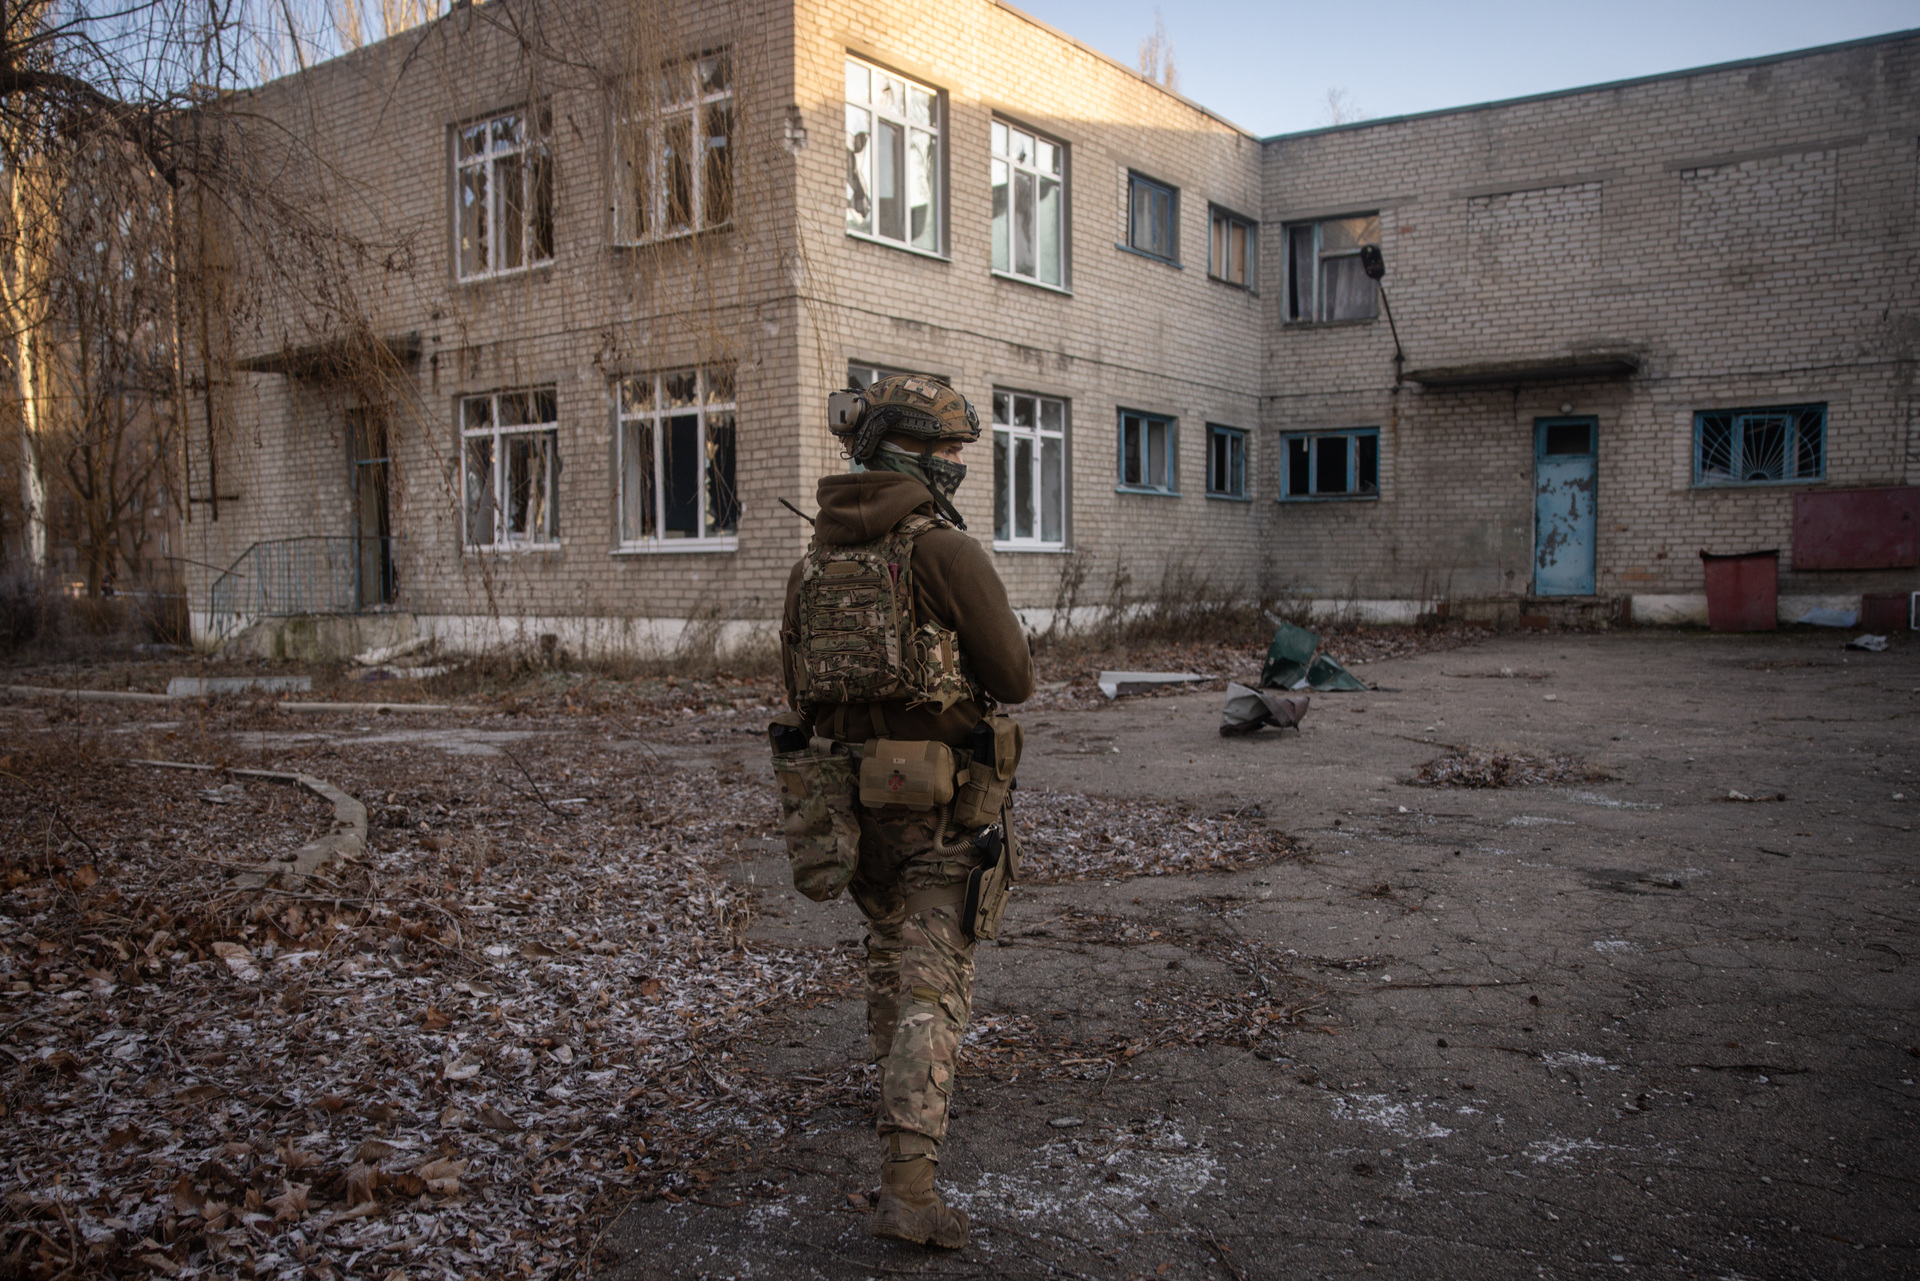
[461,388,561,551]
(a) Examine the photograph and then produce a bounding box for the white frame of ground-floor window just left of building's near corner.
[612,365,741,555]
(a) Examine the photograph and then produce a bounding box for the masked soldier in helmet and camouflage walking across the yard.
[783,376,1033,1248]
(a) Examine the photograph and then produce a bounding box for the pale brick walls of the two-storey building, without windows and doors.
[188,0,1920,641]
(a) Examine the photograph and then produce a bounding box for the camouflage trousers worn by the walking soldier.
[849,805,975,1158]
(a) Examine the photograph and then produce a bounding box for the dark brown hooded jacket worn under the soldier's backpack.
[781,472,1033,745]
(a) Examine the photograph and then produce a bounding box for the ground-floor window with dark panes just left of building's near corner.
[614,365,739,551]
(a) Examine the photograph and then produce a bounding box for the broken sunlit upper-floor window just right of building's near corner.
[847,58,943,254]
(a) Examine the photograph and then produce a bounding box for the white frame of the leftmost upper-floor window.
[453,104,555,280]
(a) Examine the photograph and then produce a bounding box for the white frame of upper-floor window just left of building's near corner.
[612,48,737,246]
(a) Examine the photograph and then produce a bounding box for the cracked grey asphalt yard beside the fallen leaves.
[601,632,1920,1279]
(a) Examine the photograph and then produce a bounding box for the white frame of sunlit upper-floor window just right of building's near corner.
[845,54,947,257]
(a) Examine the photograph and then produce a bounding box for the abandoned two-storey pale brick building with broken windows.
[188,0,1920,651]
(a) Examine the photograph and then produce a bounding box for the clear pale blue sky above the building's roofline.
[1014,0,1920,136]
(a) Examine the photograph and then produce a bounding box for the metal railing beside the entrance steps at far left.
[207,534,396,640]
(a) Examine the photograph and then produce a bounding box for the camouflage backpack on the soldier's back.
[787,515,977,711]
